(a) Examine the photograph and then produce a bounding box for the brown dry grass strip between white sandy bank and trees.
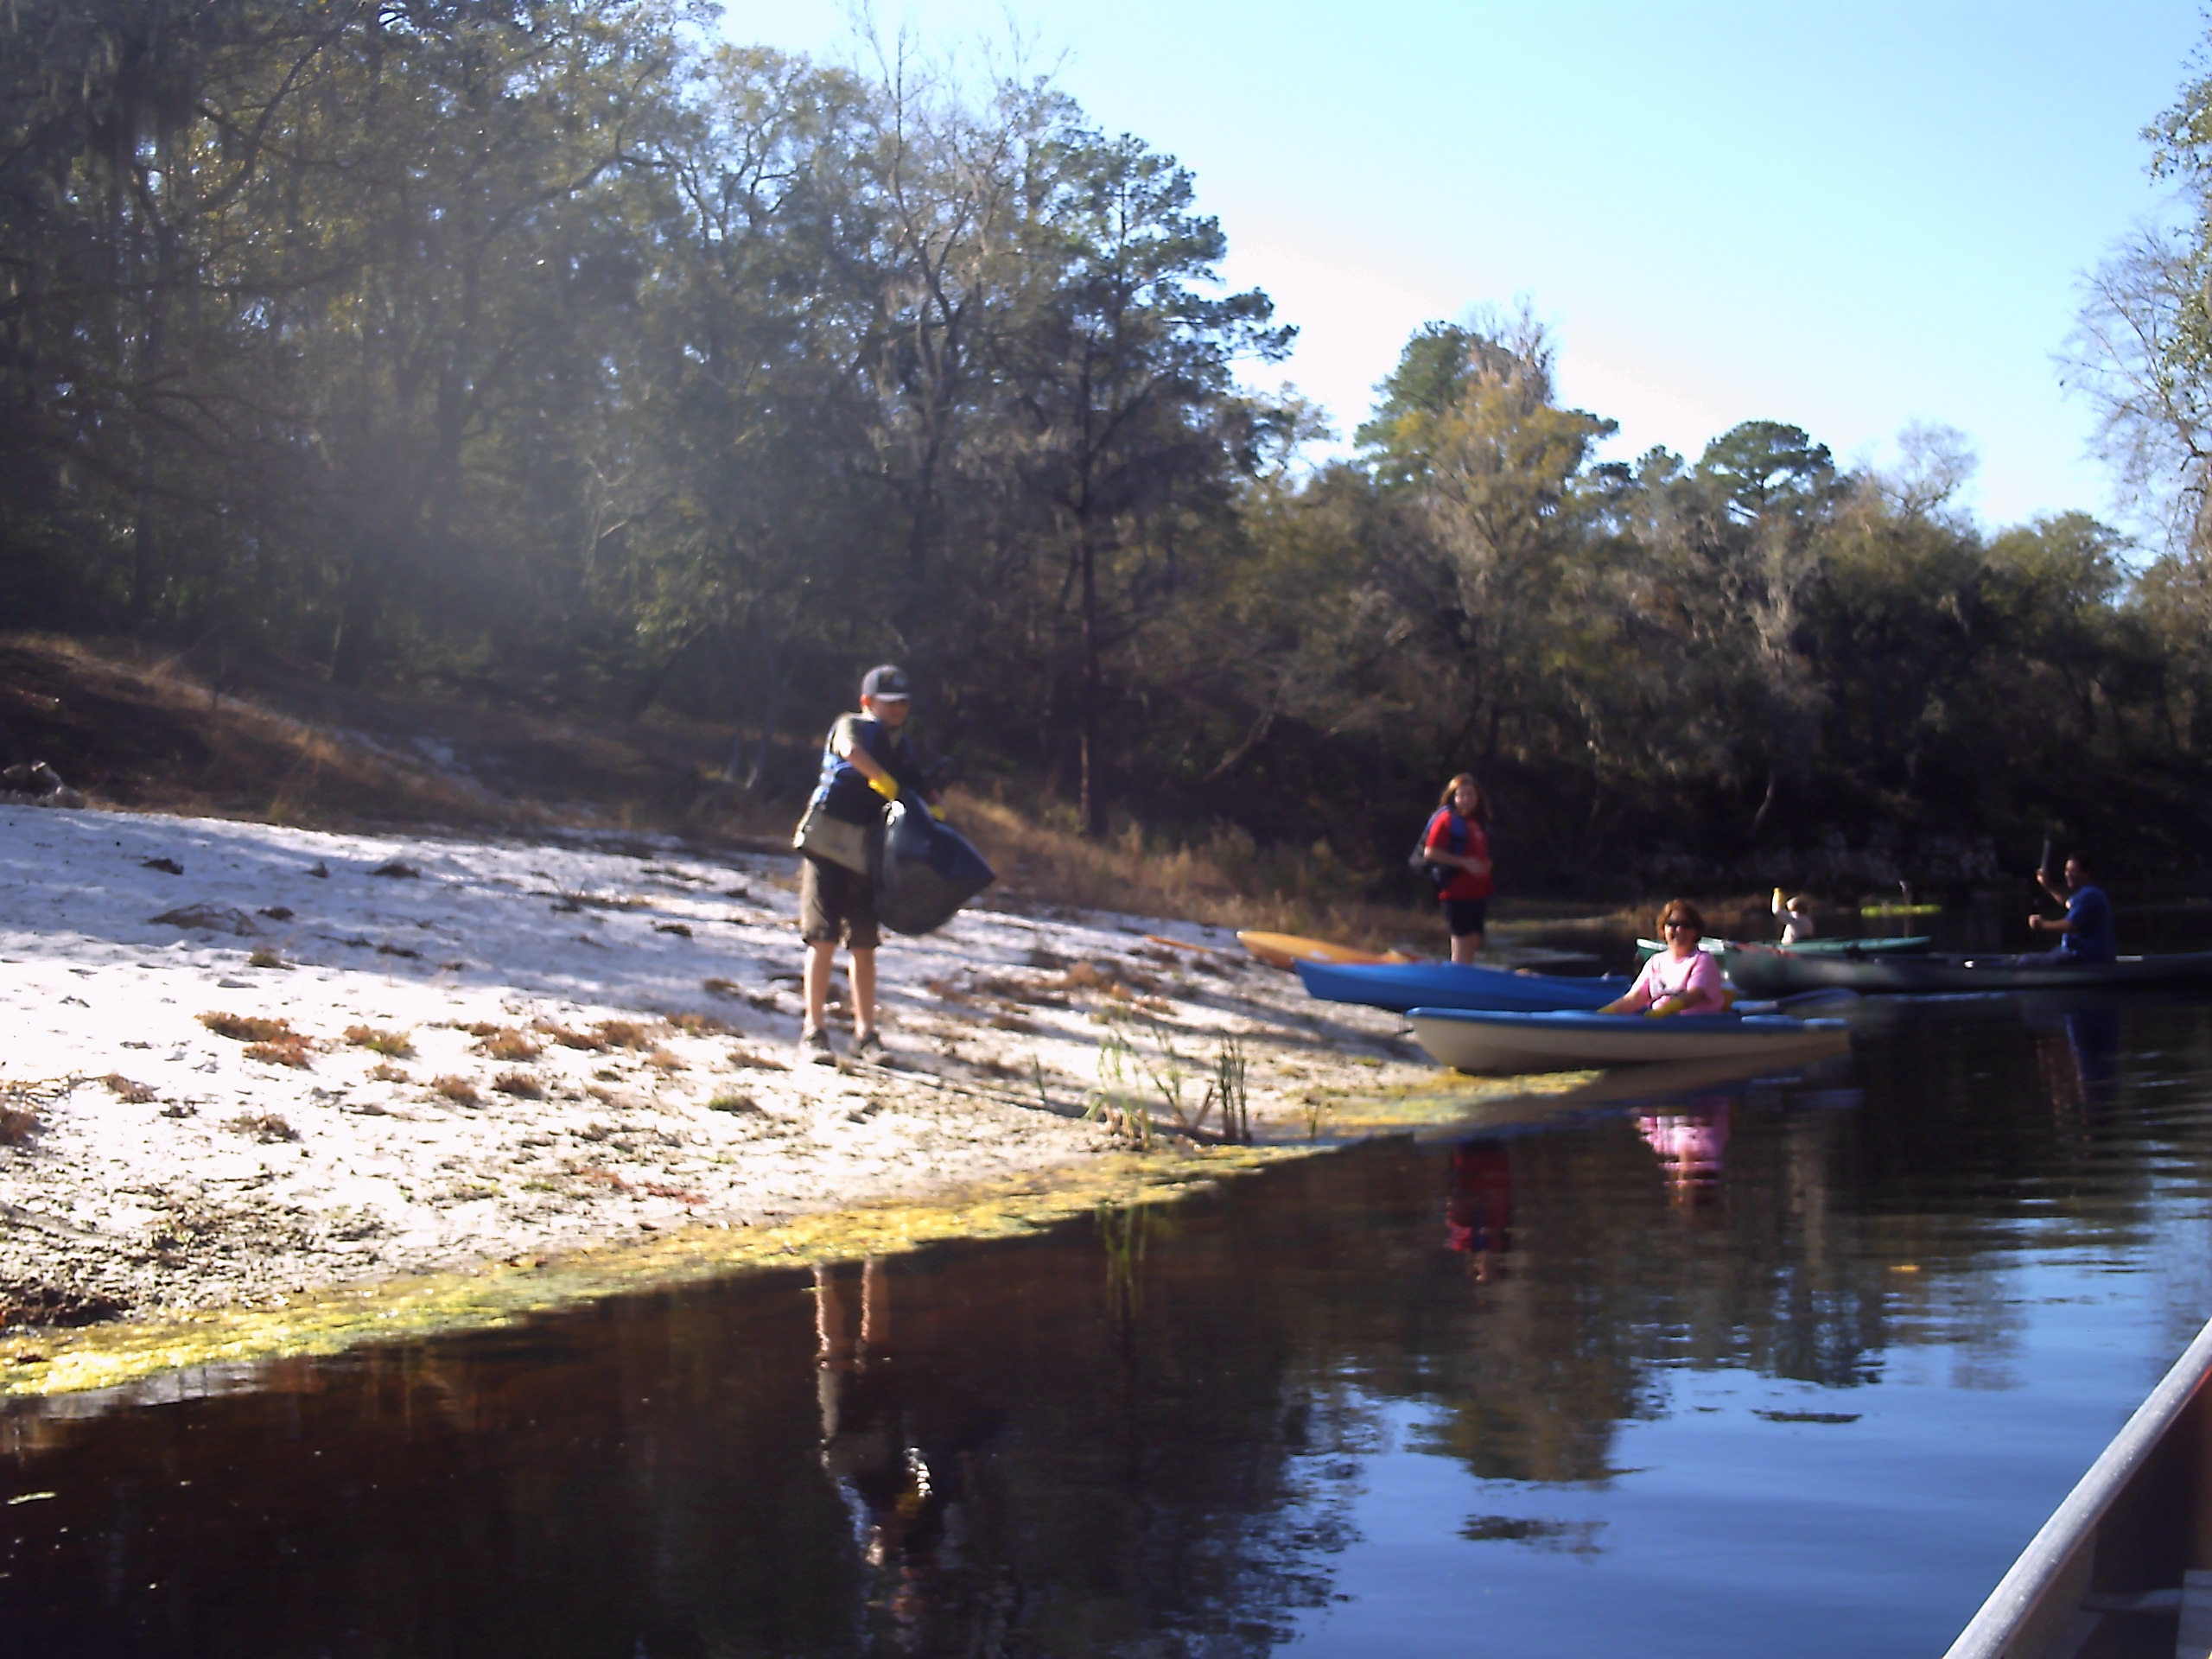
[0,632,1663,956]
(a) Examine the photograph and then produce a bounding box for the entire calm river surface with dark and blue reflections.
[13,982,2212,1659]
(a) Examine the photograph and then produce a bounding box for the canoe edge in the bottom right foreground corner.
[1944,1323,2212,1659]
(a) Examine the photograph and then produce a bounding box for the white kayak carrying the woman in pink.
[1407,1008,1849,1073]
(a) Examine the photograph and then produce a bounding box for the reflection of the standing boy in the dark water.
[814,1259,947,1652]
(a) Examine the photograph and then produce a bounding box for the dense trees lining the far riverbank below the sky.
[0,0,2212,889]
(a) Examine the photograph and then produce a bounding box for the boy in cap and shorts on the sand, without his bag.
[791,664,927,1066]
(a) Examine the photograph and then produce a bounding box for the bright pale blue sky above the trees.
[726,0,2205,524]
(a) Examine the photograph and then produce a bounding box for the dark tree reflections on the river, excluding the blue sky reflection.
[0,1008,2208,1655]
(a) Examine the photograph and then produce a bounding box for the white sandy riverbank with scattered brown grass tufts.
[0,807,1433,1362]
